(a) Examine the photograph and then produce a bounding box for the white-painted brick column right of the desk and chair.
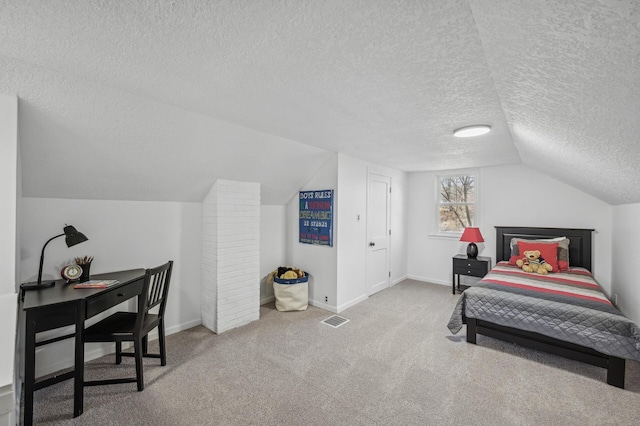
[202,180,260,333]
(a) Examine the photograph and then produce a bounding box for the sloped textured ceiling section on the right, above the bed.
[470,0,640,204]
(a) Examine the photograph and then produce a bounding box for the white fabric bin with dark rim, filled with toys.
[268,266,309,312]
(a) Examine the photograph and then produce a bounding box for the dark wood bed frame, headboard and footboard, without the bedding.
[466,226,625,388]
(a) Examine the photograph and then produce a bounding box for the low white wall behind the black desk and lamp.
[21,198,202,375]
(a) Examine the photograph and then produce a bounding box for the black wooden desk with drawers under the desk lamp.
[22,269,145,426]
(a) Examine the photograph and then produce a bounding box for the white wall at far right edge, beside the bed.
[611,204,640,324]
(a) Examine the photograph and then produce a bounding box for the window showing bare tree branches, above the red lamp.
[436,174,477,233]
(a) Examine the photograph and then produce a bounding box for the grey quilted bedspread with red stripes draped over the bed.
[448,262,640,361]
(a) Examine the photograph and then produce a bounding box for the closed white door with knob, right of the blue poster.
[367,173,391,295]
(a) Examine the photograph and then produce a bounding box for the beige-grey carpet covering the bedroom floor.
[23,280,640,425]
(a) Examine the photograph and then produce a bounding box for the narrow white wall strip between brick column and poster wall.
[260,206,287,304]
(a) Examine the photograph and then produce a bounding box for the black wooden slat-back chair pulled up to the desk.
[83,261,173,391]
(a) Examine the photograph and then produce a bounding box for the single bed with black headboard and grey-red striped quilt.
[448,226,640,388]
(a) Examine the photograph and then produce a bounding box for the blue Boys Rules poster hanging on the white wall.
[298,189,333,247]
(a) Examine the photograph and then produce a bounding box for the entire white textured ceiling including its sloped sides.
[0,0,640,204]
